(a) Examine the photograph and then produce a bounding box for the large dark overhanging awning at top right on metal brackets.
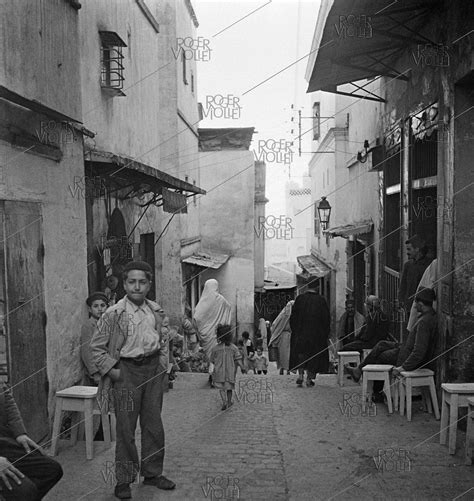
[306,0,442,96]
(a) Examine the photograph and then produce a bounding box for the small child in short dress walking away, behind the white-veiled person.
[209,324,245,411]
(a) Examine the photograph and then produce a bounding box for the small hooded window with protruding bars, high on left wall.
[99,31,127,96]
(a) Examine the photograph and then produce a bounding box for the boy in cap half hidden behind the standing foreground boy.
[80,292,109,386]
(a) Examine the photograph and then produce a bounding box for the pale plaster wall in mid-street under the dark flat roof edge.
[200,150,255,332]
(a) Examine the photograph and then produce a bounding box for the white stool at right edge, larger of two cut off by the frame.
[439,383,474,454]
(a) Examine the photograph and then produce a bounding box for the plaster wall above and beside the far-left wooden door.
[0,0,87,415]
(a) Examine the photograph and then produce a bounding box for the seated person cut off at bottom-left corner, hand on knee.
[0,386,63,501]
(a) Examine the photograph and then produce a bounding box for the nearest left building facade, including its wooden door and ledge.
[0,0,90,441]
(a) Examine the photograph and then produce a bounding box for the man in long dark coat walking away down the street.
[290,284,330,387]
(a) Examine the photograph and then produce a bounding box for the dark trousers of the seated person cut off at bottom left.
[0,437,63,501]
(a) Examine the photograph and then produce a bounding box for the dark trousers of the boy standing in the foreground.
[113,356,165,484]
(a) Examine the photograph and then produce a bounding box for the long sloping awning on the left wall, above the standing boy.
[85,150,206,210]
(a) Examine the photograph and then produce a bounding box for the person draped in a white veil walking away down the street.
[194,278,232,387]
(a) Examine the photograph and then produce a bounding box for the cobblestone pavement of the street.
[46,364,474,501]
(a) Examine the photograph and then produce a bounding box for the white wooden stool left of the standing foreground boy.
[51,386,115,459]
